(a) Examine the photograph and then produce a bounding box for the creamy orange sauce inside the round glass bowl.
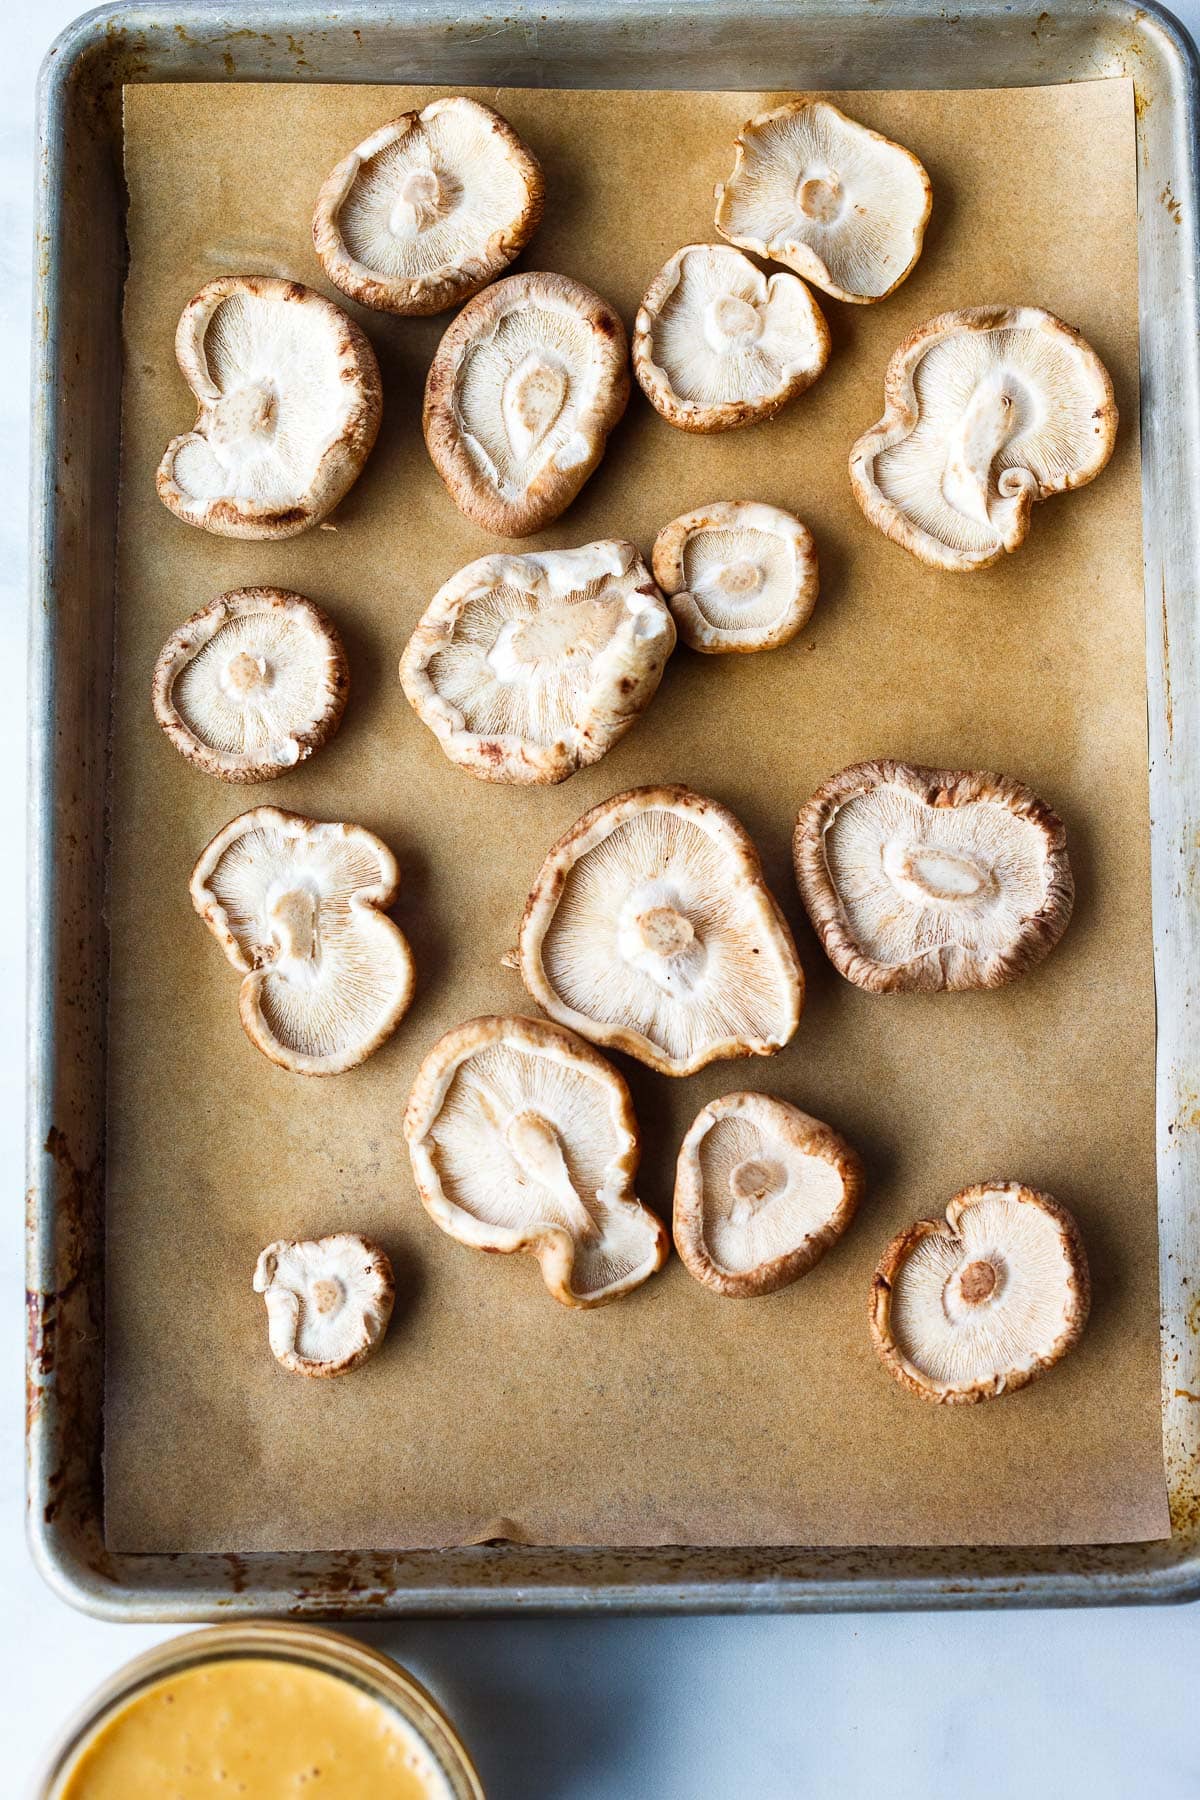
[58,1656,452,1800]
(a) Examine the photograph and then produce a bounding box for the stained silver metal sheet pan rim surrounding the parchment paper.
[27,0,1200,1620]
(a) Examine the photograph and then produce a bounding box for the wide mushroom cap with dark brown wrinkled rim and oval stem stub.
[793,761,1074,994]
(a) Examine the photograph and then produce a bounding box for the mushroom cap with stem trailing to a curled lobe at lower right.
[405,1019,669,1307]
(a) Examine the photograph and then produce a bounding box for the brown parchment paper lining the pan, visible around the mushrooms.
[106,81,1168,1550]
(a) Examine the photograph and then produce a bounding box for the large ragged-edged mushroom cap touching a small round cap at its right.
[399,540,675,783]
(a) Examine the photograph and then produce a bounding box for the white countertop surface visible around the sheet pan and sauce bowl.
[9,0,1200,1800]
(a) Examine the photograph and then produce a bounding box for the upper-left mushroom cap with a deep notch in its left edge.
[157,275,383,538]
